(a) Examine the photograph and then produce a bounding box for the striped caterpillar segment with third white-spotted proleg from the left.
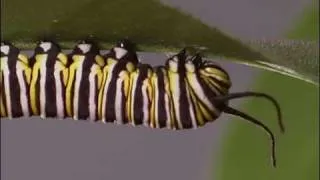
[65,42,105,121]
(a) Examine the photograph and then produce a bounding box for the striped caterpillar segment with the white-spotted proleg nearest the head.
[99,43,139,124]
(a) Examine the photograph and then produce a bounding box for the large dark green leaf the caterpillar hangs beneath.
[1,0,319,84]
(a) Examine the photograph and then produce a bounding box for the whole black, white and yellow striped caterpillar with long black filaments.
[0,40,284,166]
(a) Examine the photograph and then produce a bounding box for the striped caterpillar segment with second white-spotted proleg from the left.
[29,42,68,118]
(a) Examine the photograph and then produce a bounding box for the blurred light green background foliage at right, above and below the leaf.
[213,6,319,180]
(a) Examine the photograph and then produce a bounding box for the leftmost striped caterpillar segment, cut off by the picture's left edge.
[0,42,31,118]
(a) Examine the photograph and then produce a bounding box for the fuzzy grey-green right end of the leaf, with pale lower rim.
[248,40,319,85]
